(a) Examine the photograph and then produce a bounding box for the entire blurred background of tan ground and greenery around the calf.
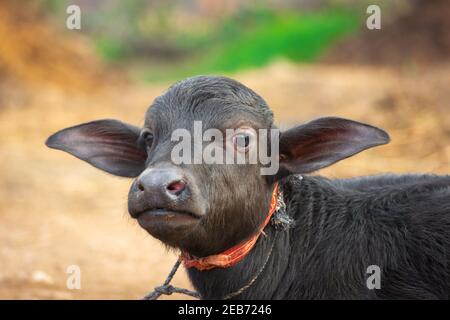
[0,0,450,299]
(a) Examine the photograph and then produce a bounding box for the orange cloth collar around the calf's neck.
[180,183,278,271]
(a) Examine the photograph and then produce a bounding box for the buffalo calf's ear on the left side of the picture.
[45,120,147,177]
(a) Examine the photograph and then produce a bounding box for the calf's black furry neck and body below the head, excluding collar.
[188,175,450,299]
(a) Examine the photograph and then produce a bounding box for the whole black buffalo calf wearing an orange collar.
[47,76,450,299]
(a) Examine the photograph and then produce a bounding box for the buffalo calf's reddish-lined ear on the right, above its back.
[280,117,389,174]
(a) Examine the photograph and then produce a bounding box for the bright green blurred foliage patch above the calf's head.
[183,10,359,72]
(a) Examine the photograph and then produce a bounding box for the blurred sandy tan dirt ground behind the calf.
[0,61,450,299]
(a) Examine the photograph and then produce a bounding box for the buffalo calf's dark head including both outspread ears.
[47,76,389,256]
